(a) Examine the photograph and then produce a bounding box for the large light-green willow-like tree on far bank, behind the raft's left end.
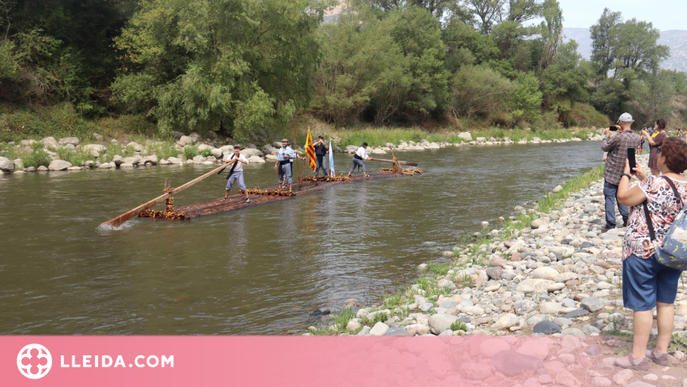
[112,0,327,139]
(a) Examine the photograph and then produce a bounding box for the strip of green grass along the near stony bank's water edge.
[310,164,604,335]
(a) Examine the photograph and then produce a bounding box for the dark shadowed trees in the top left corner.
[0,0,135,114]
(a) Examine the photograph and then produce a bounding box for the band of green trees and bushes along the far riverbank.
[0,0,687,142]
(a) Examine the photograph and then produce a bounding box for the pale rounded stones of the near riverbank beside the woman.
[311,155,687,338]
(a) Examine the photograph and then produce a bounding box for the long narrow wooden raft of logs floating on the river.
[139,172,410,220]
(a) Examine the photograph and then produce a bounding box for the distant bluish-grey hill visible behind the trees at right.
[563,28,687,72]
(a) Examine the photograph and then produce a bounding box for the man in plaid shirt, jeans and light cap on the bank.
[601,113,642,232]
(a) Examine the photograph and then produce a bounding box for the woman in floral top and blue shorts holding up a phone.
[615,137,687,370]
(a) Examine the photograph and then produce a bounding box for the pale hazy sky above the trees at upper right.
[558,0,687,31]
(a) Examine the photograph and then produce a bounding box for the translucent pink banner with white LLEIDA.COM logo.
[0,336,686,387]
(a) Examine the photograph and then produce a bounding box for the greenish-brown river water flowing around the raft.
[0,142,602,335]
